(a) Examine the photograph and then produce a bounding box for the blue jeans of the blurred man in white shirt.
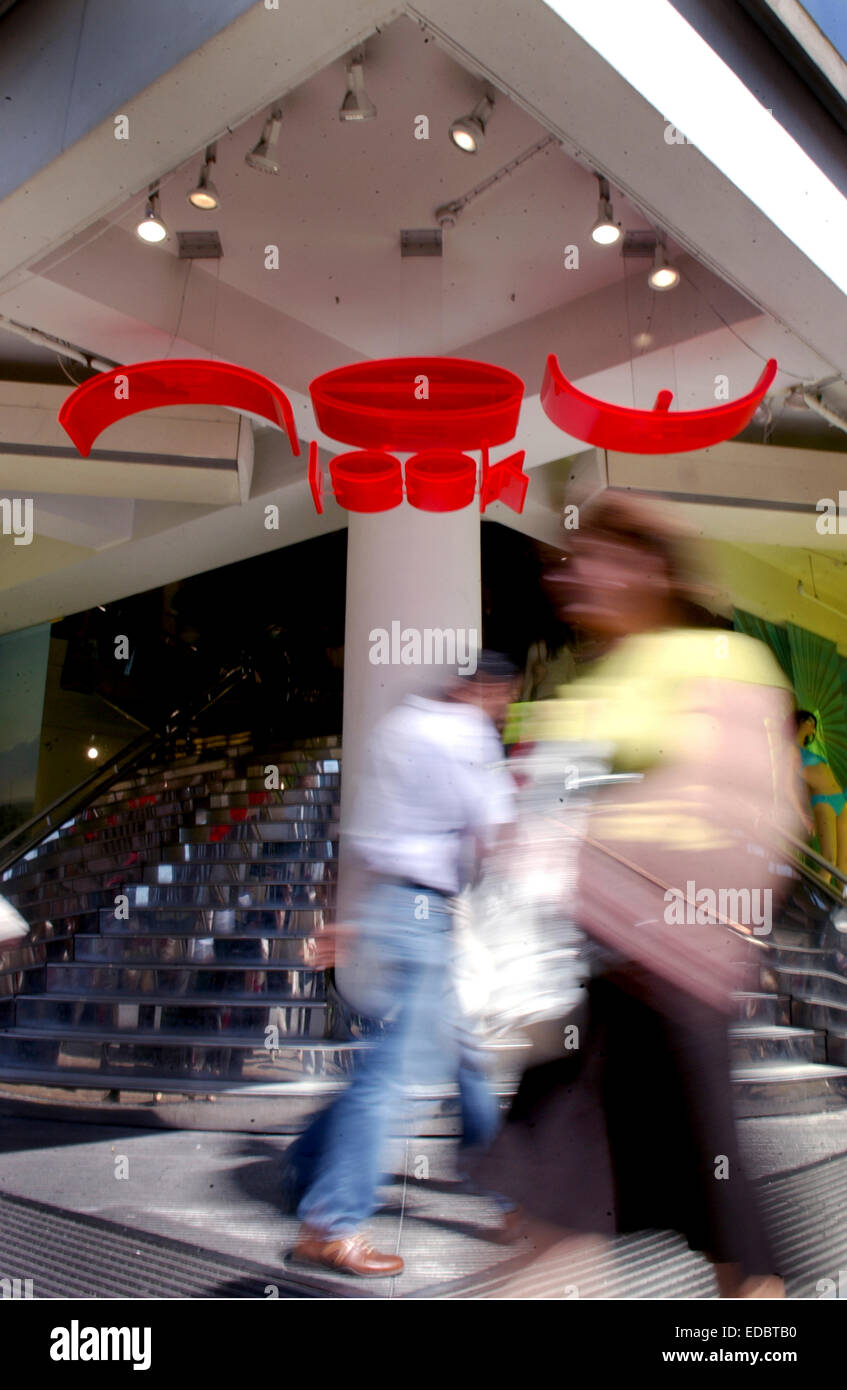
[287,880,499,1237]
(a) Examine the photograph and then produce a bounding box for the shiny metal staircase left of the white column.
[0,739,353,1093]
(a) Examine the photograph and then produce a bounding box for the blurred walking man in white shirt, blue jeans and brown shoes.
[287,652,519,1277]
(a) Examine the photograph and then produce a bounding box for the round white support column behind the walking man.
[338,498,481,1002]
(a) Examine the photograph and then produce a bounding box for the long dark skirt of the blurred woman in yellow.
[474,966,777,1275]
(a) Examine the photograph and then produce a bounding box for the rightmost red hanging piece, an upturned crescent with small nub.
[541,353,776,453]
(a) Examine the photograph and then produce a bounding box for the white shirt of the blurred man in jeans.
[349,695,515,894]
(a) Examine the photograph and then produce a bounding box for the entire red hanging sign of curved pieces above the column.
[58,353,776,512]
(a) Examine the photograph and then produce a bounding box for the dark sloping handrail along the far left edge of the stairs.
[0,657,255,874]
